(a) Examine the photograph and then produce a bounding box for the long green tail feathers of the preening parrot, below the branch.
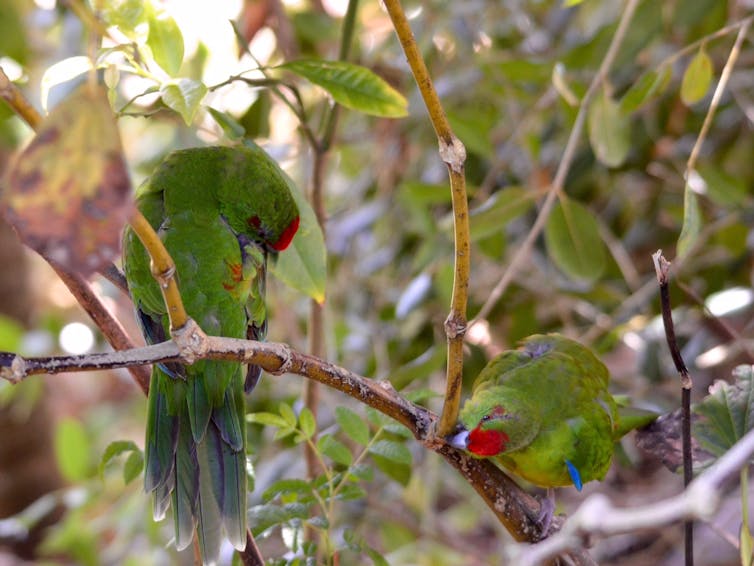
[144,362,246,564]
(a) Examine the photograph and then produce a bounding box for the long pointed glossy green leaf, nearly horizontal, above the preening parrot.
[277,59,408,118]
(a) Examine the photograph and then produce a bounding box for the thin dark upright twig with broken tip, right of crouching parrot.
[652,250,694,566]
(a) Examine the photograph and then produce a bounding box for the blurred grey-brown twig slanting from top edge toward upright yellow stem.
[469,0,639,326]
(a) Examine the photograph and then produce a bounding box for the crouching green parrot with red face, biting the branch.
[450,334,658,491]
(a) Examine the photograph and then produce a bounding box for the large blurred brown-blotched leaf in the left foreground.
[1,83,133,275]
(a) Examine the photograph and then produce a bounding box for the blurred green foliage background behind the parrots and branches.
[0,0,754,564]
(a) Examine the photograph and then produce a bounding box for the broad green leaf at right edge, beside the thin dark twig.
[692,365,754,457]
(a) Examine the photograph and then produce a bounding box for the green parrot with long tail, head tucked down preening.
[123,147,299,564]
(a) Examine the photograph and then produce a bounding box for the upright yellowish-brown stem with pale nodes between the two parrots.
[385,0,471,436]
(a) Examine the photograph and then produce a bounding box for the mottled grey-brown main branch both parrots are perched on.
[0,336,590,564]
